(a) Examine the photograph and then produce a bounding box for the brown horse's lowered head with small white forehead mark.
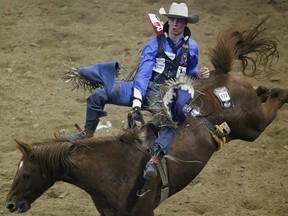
[6,140,72,212]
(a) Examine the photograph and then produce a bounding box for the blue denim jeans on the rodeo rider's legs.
[85,81,175,154]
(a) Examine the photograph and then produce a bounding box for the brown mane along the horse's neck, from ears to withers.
[29,129,140,181]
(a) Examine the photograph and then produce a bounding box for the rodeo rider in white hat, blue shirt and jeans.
[60,2,210,180]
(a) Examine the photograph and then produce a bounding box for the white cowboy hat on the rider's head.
[159,2,199,24]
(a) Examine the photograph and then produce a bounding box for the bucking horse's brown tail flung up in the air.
[209,17,279,77]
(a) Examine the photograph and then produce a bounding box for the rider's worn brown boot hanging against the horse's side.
[143,145,164,180]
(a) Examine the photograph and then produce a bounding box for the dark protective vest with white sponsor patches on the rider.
[152,35,190,84]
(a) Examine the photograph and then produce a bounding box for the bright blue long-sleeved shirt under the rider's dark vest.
[133,34,198,98]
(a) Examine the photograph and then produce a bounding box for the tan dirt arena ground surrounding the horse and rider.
[0,0,288,216]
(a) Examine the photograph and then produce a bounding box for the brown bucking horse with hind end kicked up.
[6,20,288,216]
